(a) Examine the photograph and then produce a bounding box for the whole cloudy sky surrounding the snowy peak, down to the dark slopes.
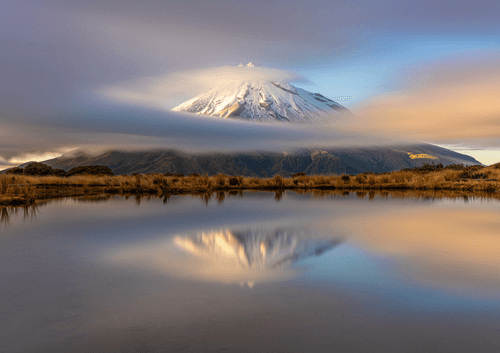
[0,0,500,169]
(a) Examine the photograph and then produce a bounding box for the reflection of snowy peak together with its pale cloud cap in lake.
[106,227,340,288]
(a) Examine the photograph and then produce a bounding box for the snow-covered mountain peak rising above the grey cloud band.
[172,62,348,123]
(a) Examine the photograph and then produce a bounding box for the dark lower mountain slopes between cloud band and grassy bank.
[44,144,480,177]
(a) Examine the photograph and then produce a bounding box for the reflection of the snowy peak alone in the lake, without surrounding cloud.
[175,228,338,269]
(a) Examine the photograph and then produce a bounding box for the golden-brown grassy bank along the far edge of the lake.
[0,166,500,206]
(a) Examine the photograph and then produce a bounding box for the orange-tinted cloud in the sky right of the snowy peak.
[354,53,500,141]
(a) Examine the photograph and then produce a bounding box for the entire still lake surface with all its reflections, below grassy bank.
[0,193,500,352]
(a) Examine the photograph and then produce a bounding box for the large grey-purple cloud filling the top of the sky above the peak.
[0,0,500,112]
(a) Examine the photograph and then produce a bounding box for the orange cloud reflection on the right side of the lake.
[337,206,500,296]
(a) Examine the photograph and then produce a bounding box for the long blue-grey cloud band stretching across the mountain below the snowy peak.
[0,97,406,164]
